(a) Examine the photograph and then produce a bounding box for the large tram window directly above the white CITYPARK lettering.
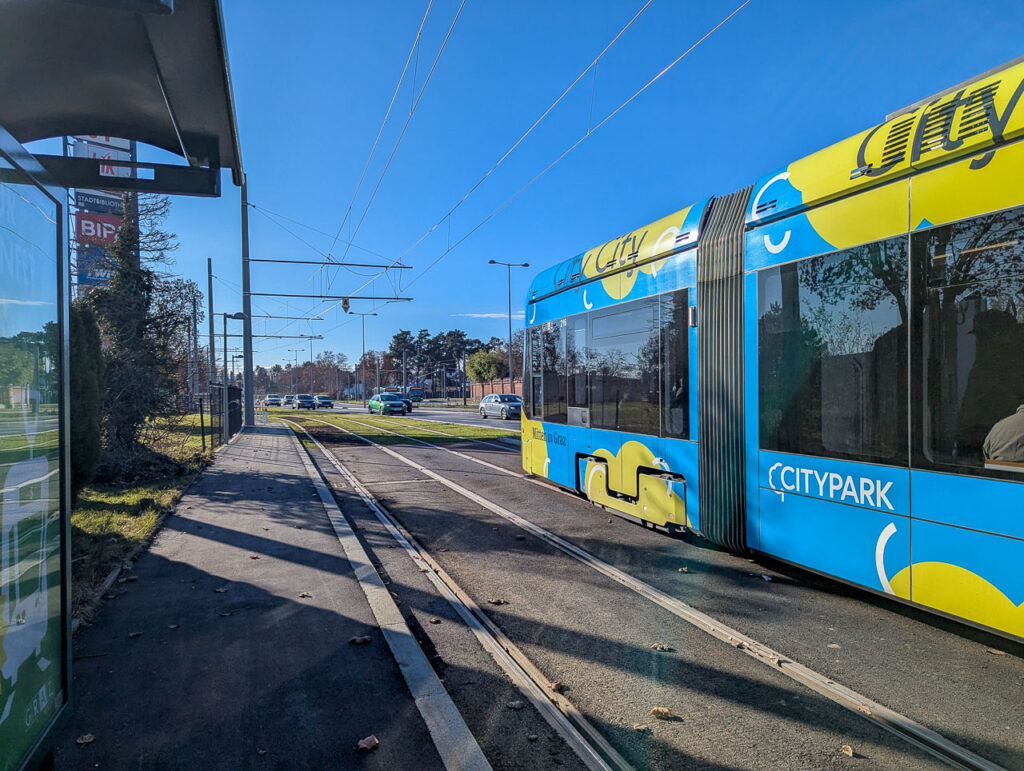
[758,237,908,464]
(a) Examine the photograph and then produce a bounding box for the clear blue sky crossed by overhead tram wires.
[151,0,1024,366]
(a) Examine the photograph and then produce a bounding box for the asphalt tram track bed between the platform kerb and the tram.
[280,410,1024,768]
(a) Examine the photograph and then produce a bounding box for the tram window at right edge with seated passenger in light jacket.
[911,207,1024,479]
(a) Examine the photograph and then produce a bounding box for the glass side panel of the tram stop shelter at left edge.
[0,157,65,768]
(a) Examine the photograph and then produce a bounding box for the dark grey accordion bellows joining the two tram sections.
[697,187,753,552]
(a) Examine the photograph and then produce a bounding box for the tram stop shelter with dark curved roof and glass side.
[0,0,243,769]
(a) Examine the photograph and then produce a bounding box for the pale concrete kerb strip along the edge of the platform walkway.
[282,419,490,771]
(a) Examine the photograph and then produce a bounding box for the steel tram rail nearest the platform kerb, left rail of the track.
[284,424,631,771]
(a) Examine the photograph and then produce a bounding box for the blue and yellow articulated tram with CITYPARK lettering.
[522,57,1024,638]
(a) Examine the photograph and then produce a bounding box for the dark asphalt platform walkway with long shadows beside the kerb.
[56,427,441,769]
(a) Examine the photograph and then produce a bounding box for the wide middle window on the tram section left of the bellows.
[590,297,660,436]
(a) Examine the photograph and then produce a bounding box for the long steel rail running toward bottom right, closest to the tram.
[303,419,1001,771]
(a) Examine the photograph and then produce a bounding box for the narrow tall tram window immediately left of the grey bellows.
[662,289,690,438]
